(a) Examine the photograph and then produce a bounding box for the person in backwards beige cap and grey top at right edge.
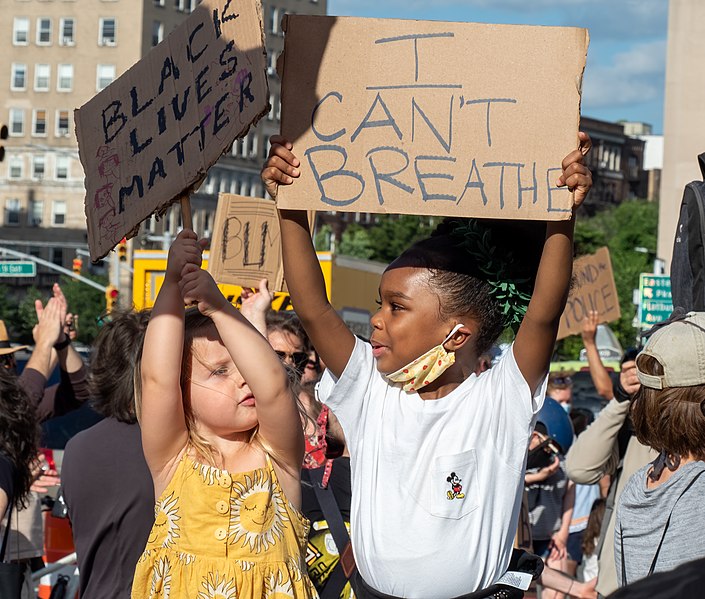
[614,312,705,597]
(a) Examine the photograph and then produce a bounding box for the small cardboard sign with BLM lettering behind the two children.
[208,193,284,291]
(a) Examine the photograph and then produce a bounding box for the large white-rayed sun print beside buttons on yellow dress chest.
[228,470,289,554]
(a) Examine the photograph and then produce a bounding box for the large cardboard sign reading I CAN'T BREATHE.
[278,15,588,220]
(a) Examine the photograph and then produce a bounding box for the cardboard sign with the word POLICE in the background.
[558,247,621,339]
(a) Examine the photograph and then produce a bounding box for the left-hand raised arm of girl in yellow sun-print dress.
[140,229,201,486]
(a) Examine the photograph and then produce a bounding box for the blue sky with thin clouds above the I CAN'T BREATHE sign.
[328,0,668,133]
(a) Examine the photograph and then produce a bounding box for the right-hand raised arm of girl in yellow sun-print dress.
[181,264,304,476]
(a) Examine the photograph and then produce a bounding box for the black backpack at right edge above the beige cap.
[671,153,705,312]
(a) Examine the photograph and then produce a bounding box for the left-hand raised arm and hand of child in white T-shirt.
[262,136,355,377]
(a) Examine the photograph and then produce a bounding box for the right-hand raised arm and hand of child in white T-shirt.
[514,132,592,393]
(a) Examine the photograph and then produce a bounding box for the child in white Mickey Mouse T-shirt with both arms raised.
[262,134,591,599]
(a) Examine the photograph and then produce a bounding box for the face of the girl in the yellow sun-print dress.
[190,335,257,437]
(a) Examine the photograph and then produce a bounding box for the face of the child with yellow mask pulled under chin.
[370,267,456,374]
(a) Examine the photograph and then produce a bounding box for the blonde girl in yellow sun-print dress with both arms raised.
[132,230,314,599]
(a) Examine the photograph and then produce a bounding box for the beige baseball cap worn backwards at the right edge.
[636,312,705,389]
